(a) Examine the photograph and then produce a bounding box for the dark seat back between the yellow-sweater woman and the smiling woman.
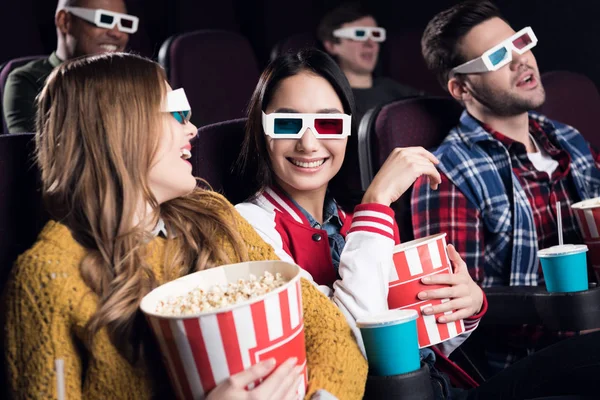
[190,118,251,204]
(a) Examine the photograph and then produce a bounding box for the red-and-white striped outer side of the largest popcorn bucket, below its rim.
[147,279,308,399]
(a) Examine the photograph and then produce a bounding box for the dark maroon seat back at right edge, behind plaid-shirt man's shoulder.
[539,71,600,150]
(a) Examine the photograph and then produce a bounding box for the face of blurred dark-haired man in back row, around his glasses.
[328,16,379,74]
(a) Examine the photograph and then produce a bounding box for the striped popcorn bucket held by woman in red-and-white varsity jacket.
[388,233,465,348]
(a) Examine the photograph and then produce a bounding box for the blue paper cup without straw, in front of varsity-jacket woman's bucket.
[356,310,420,376]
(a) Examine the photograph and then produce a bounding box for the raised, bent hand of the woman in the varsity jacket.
[362,147,442,206]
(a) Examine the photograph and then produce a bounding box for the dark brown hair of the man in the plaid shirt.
[421,0,504,90]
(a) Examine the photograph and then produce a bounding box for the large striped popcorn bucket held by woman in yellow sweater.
[140,261,308,399]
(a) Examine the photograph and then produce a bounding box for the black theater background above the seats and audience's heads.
[0,0,600,90]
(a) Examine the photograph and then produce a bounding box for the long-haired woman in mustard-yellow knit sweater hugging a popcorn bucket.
[4,54,367,400]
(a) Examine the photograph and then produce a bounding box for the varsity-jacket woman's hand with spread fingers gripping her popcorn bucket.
[418,244,483,323]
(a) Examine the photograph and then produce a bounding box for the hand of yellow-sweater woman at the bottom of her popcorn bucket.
[207,358,304,400]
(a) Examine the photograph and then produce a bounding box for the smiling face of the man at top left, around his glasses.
[57,0,129,58]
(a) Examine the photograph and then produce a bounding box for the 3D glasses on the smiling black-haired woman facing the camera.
[262,112,352,139]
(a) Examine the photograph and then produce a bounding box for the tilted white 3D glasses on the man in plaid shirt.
[450,26,537,76]
